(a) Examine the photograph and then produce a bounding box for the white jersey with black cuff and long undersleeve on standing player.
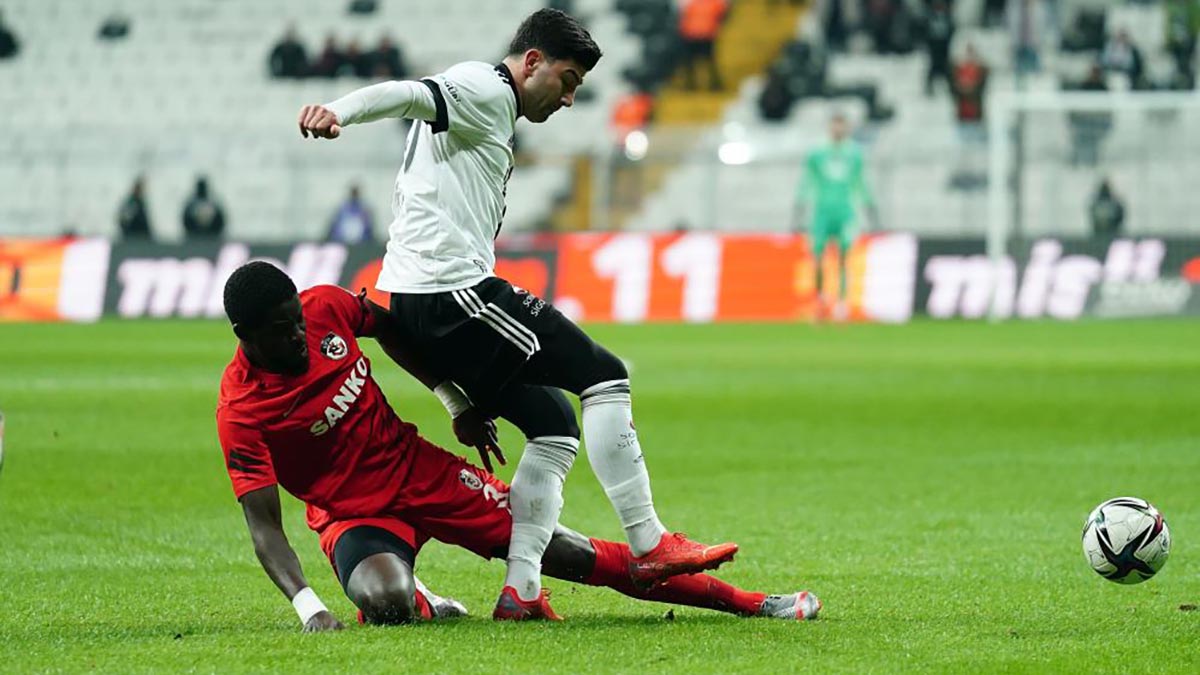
[328,61,521,293]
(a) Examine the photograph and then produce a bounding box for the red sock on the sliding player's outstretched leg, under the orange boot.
[584,539,767,615]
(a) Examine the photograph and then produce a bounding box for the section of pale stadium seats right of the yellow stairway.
[626,0,1200,237]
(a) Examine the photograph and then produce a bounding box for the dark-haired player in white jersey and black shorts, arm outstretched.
[299,10,738,620]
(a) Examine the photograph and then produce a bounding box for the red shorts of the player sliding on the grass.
[320,438,512,563]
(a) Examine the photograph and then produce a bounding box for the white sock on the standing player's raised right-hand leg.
[580,380,666,556]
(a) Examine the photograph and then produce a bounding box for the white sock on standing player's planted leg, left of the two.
[504,436,580,601]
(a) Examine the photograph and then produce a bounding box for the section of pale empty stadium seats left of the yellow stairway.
[0,0,638,240]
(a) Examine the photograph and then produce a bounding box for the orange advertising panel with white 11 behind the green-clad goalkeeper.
[552,232,917,323]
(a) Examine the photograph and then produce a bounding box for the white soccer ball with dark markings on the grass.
[1084,497,1171,584]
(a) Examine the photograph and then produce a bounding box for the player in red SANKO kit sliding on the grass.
[217,262,821,631]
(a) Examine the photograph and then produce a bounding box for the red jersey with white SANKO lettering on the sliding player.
[217,286,418,532]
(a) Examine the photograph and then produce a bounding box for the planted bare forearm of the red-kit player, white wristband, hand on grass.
[241,485,342,633]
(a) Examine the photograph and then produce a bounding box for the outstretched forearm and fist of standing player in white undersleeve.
[299,80,437,138]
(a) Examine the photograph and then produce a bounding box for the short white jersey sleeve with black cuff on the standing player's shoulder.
[421,64,516,136]
